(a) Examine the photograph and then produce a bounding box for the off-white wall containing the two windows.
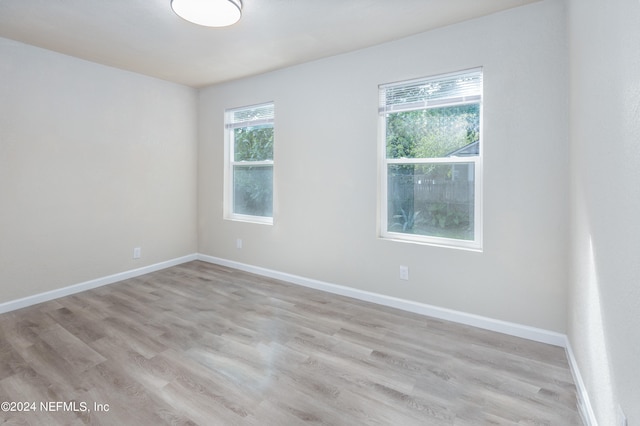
[199,1,569,332]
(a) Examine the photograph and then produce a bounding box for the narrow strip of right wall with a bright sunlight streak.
[568,0,640,425]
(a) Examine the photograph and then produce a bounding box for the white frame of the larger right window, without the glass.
[378,67,484,251]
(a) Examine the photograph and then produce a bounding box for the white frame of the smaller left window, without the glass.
[223,101,275,225]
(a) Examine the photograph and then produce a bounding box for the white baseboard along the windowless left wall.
[0,254,198,314]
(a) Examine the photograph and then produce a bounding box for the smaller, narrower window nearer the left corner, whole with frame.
[225,103,274,223]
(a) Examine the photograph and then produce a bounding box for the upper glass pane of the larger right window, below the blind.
[386,103,480,158]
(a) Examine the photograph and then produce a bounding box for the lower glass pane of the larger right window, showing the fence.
[387,163,475,240]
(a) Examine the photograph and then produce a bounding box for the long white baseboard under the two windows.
[198,254,567,347]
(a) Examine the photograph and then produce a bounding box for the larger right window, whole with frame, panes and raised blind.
[379,69,482,249]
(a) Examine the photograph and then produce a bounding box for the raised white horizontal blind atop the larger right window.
[378,68,482,114]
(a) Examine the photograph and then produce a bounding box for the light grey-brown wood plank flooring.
[0,262,581,426]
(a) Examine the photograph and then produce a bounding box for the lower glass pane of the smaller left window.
[233,165,273,217]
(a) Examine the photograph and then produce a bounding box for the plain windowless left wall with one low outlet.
[0,39,197,303]
